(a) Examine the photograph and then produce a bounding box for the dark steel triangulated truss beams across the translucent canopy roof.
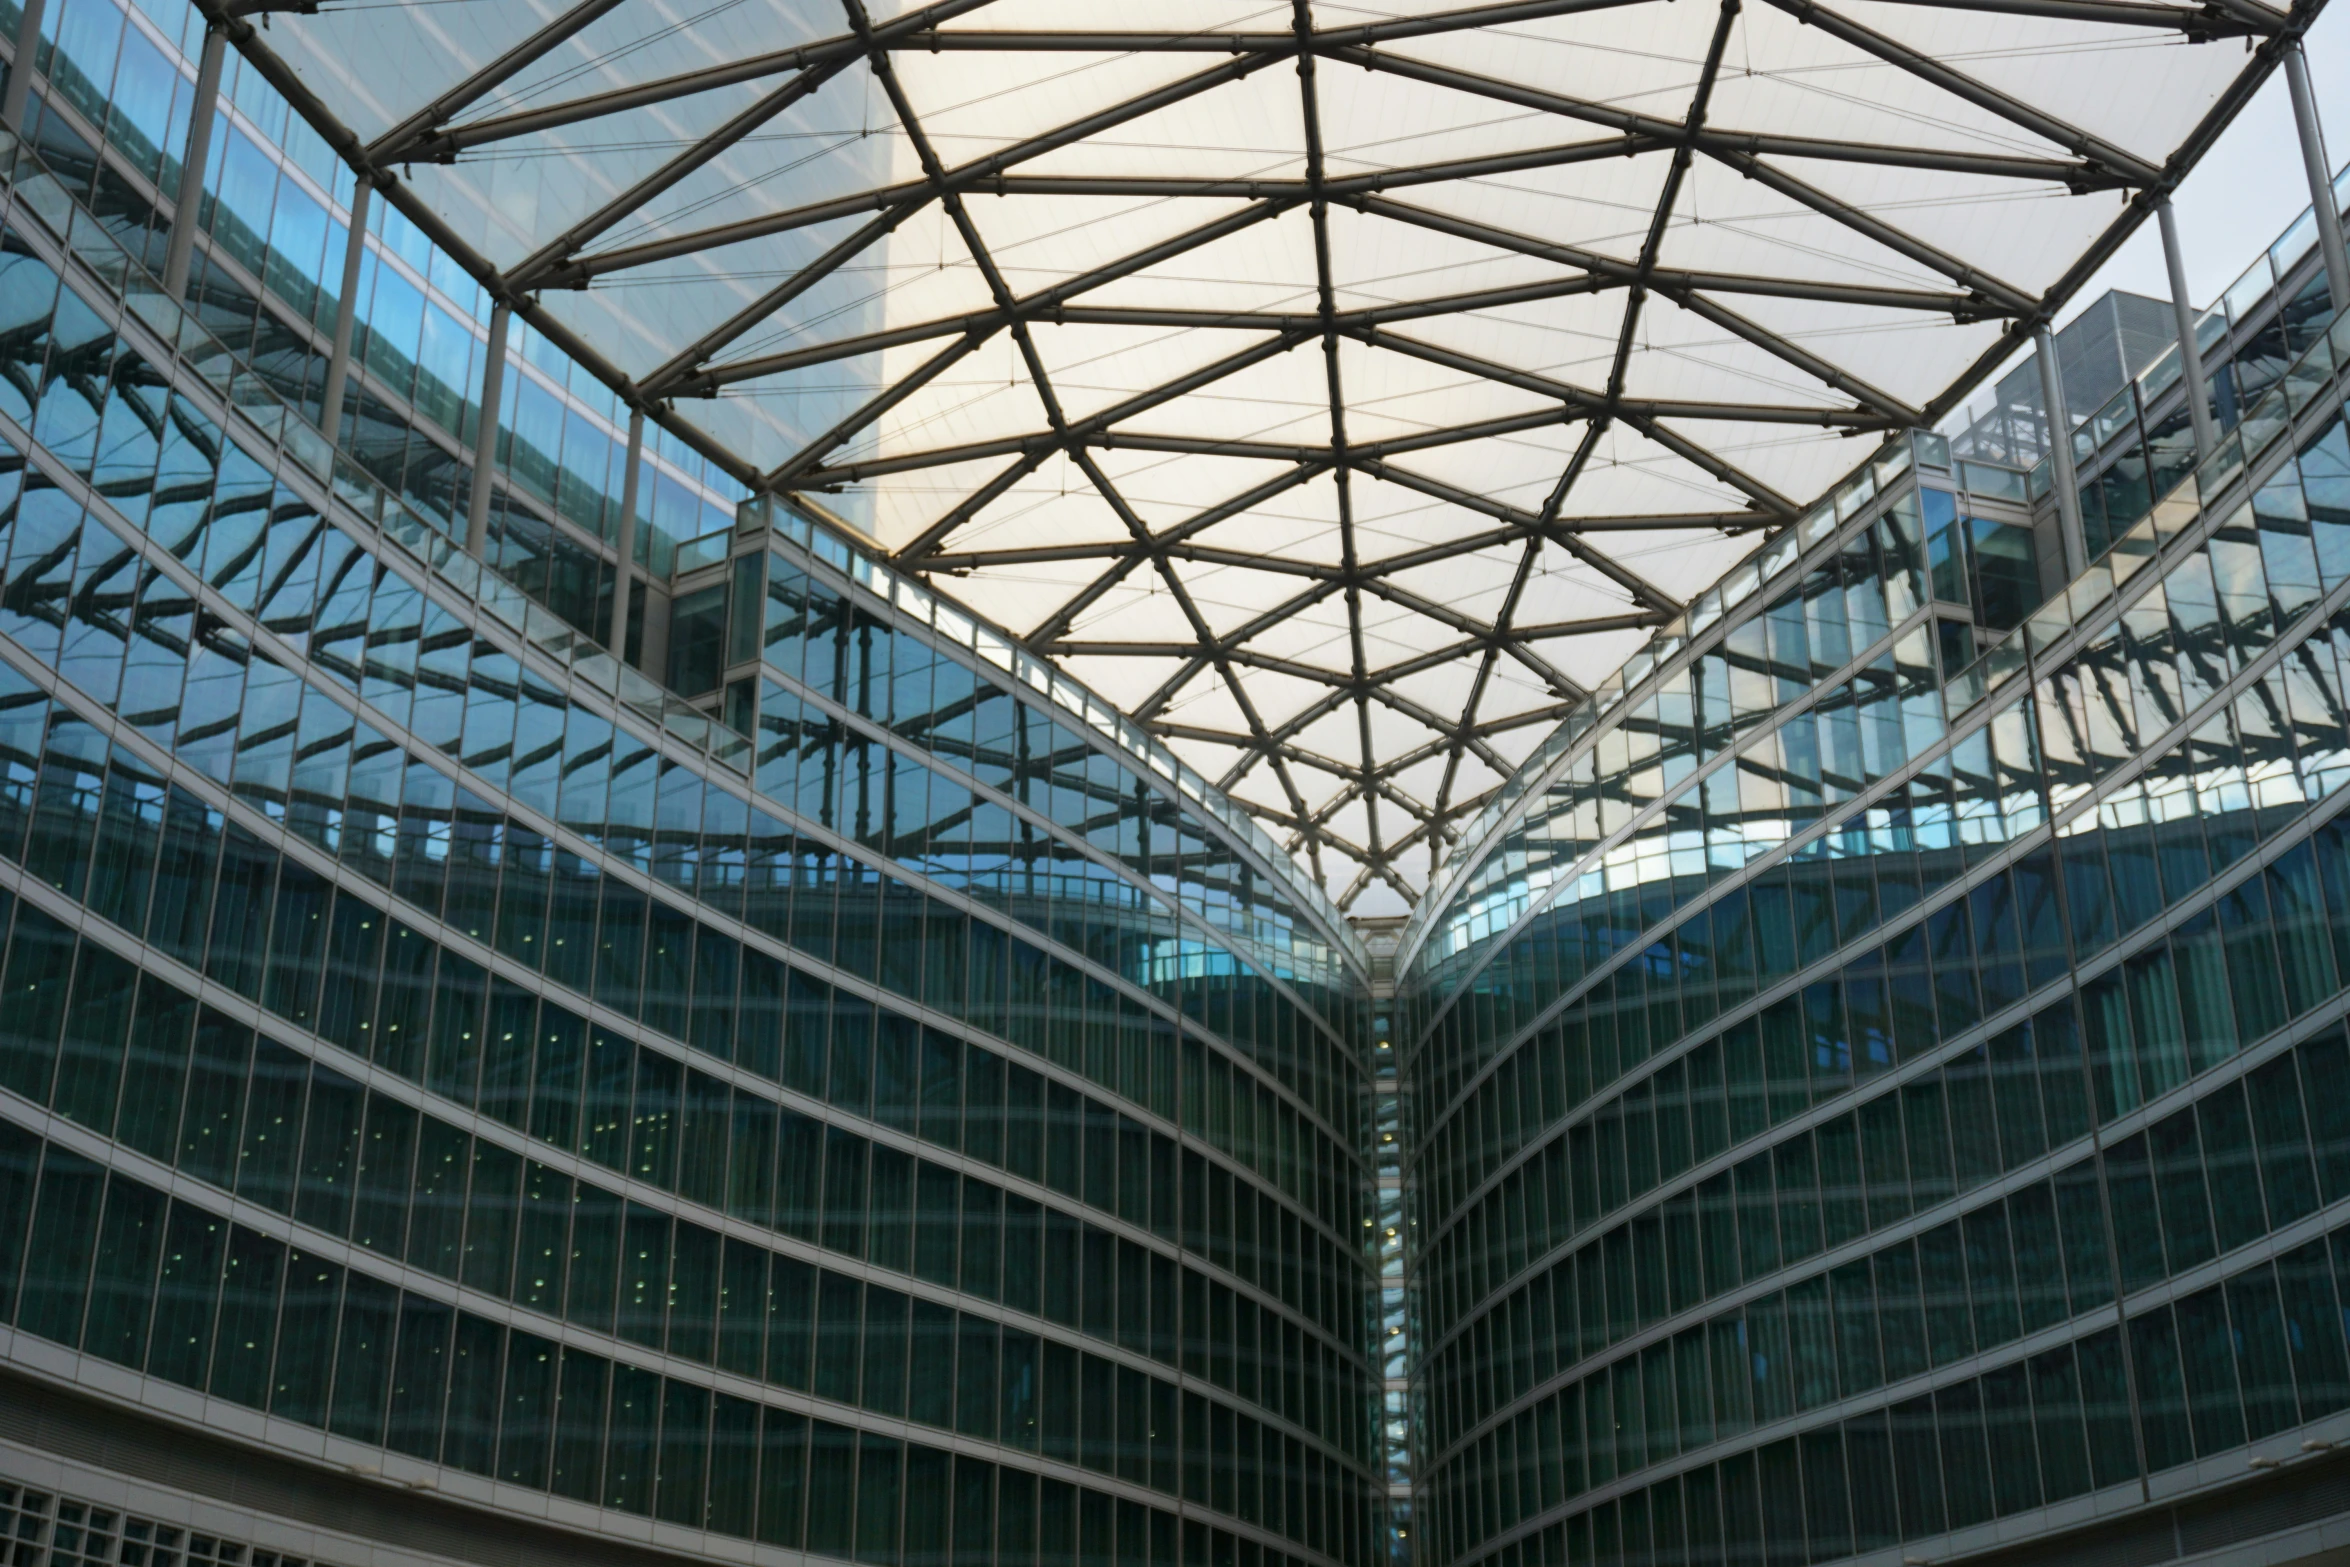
[211,0,2310,904]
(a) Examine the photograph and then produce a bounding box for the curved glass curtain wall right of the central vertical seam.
[1405,226,2350,1562]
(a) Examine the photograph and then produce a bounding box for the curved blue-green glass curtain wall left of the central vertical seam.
[0,95,1379,1567]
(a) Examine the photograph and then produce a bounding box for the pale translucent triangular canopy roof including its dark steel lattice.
[220,0,2315,912]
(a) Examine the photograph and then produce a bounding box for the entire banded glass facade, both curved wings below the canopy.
[0,0,2350,1567]
